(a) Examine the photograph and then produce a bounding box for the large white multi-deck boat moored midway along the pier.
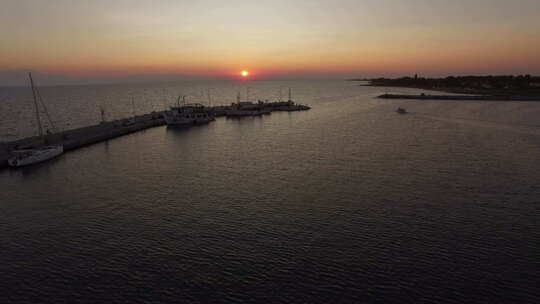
[163,96,215,126]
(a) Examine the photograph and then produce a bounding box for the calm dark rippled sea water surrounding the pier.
[0,81,540,303]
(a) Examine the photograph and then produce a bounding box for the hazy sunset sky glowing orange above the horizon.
[0,0,540,80]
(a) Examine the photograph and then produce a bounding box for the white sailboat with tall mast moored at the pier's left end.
[8,73,64,167]
